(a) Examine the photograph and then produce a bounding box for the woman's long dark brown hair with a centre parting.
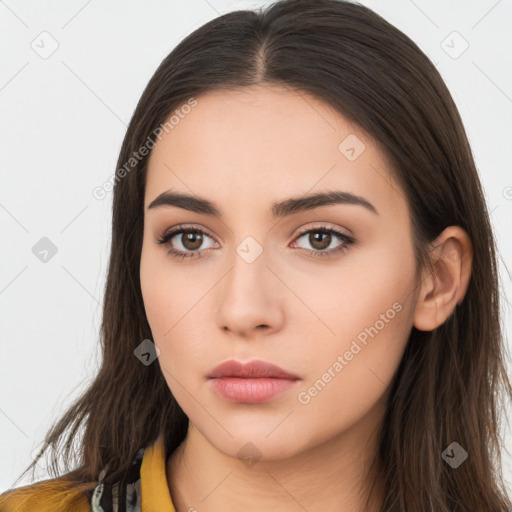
[6,0,512,512]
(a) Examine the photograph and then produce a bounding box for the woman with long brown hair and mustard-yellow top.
[0,0,512,512]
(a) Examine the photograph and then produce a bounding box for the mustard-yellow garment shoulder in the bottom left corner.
[0,477,90,512]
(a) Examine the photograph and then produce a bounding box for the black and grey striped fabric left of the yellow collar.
[91,448,145,512]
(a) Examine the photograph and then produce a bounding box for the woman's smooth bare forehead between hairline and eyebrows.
[145,86,405,220]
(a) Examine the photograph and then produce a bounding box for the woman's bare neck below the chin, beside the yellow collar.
[166,402,383,512]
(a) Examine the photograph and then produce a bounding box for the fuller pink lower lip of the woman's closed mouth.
[210,377,298,404]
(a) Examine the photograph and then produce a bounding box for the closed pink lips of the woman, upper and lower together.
[208,360,301,404]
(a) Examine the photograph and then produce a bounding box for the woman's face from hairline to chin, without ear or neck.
[140,87,416,459]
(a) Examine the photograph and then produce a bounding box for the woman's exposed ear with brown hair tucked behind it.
[413,226,473,331]
